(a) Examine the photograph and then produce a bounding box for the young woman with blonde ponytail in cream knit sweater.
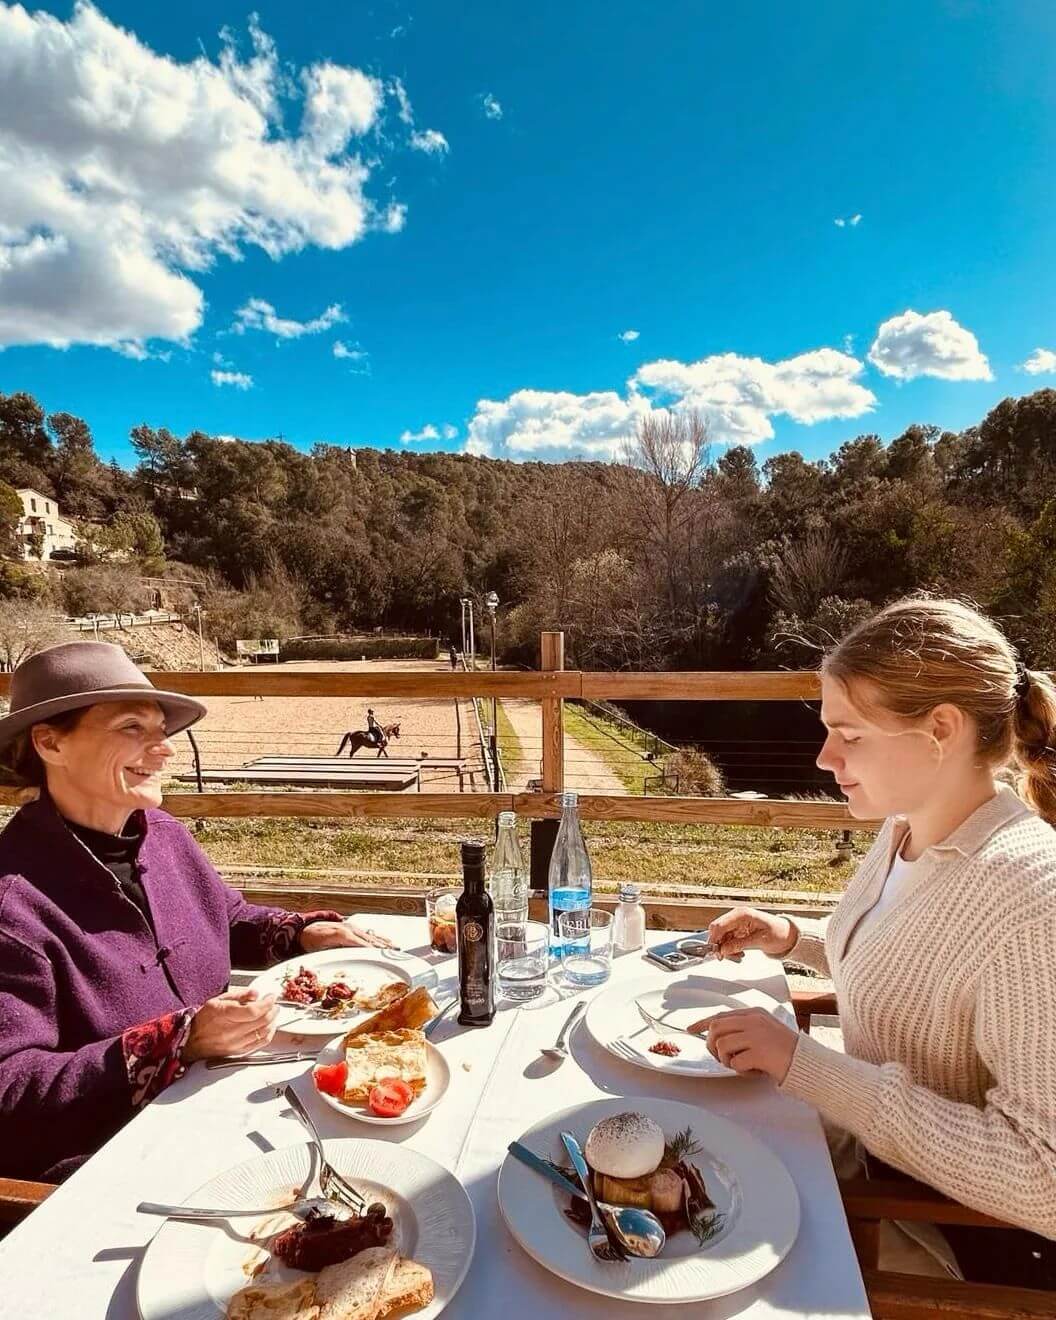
[709,598,1056,1287]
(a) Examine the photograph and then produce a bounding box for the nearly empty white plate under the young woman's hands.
[585,973,795,1077]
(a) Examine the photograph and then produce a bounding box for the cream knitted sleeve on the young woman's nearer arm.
[781,913,1056,1238]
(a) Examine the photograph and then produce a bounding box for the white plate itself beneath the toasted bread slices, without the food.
[136,1138,477,1320]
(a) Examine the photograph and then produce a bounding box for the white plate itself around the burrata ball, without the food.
[499,1097,800,1313]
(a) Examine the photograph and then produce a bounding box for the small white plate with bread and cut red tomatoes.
[312,986,451,1126]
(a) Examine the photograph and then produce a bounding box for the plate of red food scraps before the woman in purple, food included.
[251,948,436,1036]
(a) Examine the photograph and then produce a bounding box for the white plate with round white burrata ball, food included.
[498,1097,800,1312]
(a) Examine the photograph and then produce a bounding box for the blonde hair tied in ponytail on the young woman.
[821,597,1056,825]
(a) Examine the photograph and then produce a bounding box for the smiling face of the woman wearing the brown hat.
[33,701,173,833]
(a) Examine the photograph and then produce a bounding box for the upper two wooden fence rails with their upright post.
[0,632,860,830]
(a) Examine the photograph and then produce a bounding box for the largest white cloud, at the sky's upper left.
[0,0,397,355]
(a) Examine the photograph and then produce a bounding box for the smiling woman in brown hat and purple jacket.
[0,642,388,1181]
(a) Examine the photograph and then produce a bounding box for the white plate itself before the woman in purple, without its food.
[249,948,436,1036]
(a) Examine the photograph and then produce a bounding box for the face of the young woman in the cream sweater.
[817,675,950,820]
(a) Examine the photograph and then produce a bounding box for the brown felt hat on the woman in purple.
[0,642,206,747]
